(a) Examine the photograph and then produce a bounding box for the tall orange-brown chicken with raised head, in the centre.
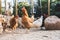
[22,7,34,33]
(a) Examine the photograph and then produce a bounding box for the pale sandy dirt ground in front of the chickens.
[0,28,60,40]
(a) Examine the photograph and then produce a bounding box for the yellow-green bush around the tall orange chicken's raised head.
[14,2,31,17]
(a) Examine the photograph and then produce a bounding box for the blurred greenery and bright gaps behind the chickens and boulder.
[1,0,60,17]
